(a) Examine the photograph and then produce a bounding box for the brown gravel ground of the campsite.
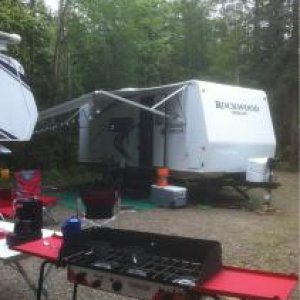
[0,172,300,300]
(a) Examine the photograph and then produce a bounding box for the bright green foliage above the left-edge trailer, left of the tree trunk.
[0,0,54,107]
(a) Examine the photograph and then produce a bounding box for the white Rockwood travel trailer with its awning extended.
[40,80,276,182]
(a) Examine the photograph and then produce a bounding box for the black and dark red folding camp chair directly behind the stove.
[77,190,121,226]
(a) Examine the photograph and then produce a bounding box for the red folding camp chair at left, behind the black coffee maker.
[13,170,58,223]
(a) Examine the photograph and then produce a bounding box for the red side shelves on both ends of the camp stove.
[14,235,298,300]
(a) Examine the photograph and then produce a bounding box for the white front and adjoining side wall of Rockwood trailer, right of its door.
[153,81,276,173]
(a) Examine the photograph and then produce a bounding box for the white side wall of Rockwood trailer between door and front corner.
[153,83,206,171]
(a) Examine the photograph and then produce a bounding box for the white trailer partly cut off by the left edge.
[0,32,38,145]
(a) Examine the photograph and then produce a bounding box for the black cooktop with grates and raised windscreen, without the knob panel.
[59,228,221,286]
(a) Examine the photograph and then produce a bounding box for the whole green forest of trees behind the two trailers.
[0,0,299,175]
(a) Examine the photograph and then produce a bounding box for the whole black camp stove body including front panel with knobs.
[60,228,222,299]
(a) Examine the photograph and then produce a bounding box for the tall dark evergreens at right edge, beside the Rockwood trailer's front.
[253,0,299,165]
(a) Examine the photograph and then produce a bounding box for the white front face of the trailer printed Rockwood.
[198,82,276,172]
